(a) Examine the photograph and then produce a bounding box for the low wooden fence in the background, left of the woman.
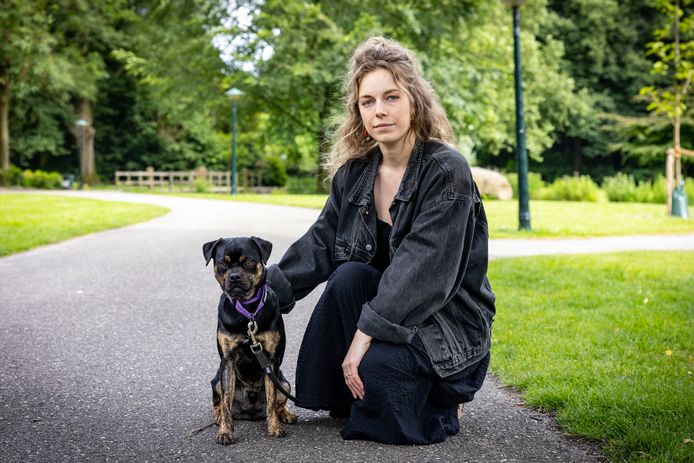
[115,167,275,193]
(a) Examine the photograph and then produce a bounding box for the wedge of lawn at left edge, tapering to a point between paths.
[0,193,168,256]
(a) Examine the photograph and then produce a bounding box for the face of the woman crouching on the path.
[357,69,412,150]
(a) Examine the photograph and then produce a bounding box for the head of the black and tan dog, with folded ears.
[202,236,272,301]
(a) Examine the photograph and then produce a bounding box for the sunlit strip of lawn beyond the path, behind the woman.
[121,190,694,238]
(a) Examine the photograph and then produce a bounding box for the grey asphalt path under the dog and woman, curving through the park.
[0,191,694,462]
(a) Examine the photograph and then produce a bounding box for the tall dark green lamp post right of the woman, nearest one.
[503,0,531,230]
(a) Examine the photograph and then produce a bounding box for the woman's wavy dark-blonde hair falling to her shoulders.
[323,37,453,177]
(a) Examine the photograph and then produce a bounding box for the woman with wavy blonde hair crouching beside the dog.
[269,37,495,444]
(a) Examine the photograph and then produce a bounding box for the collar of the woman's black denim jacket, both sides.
[349,139,424,206]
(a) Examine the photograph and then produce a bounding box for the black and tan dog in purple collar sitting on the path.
[202,237,297,445]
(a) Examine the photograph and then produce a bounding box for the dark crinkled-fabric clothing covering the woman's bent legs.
[296,262,489,444]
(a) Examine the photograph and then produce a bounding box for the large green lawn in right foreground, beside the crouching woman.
[489,252,694,462]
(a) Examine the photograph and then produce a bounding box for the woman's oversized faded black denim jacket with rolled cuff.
[268,141,495,377]
